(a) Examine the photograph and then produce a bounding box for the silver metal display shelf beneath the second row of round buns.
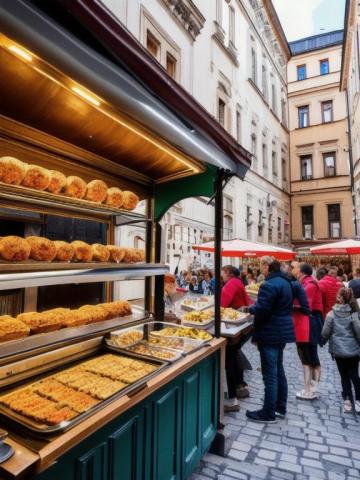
[0,263,169,290]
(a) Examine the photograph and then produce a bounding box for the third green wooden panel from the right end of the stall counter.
[153,385,181,480]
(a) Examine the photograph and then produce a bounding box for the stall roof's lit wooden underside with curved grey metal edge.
[0,0,249,185]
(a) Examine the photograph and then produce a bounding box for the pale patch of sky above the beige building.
[273,0,345,42]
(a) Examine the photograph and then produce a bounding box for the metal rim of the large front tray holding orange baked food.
[0,346,169,436]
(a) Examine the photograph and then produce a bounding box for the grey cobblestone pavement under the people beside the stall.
[190,343,360,480]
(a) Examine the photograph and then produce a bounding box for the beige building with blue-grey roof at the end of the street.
[288,30,354,246]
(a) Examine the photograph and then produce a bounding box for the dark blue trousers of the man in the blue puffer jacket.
[258,343,288,418]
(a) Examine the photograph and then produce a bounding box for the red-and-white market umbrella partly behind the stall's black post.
[193,238,296,260]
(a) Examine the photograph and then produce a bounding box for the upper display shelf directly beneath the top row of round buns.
[0,182,147,224]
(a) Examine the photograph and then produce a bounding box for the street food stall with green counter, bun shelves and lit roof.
[0,0,249,480]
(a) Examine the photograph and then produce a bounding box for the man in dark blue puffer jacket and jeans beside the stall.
[246,257,309,423]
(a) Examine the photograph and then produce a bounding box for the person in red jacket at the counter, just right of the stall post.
[221,265,253,412]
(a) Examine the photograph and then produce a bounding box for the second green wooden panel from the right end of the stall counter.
[182,370,201,478]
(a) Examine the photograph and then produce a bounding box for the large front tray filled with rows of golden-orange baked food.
[0,352,169,435]
